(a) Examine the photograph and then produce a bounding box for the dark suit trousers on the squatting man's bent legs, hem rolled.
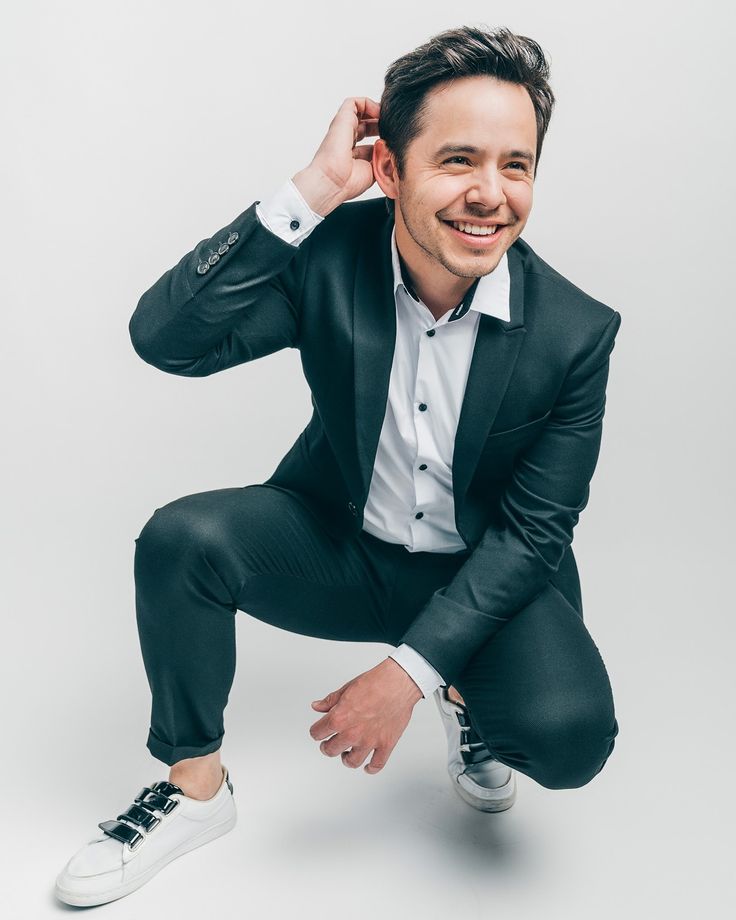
[135,485,618,789]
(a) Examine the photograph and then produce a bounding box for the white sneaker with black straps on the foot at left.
[55,766,237,907]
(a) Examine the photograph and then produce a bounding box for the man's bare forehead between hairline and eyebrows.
[416,76,537,149]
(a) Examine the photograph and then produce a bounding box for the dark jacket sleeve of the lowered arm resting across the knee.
[400,310,621,684]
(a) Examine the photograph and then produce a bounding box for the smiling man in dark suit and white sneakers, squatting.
[56,28,621,904]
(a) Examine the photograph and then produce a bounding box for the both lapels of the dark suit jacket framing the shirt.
[353,200,526,505]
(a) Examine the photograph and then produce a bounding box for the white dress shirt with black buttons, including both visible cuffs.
[256,179,511,698]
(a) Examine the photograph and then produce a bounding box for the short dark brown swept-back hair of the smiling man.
[378,26,555,178]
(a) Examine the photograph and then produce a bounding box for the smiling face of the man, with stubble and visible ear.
[374,76,537,288]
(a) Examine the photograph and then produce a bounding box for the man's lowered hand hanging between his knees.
[309,658,423,773]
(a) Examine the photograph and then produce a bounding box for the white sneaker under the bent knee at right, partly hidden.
[434,686,516,811]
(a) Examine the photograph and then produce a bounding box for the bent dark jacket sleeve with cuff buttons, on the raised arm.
[128,201,312,377]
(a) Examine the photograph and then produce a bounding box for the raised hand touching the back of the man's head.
[292,96,380,217]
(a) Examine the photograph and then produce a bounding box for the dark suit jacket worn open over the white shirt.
[130,196,621,684]
